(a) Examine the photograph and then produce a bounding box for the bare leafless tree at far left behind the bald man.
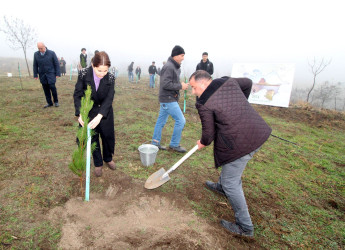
[0,16,37,76]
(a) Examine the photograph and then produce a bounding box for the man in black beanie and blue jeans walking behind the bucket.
[151,45,189,153]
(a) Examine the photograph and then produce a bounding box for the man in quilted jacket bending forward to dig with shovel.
[189,70,272,237]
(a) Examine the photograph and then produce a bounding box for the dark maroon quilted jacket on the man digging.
[196,77,272,168]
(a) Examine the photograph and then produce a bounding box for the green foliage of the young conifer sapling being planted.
[69,86,96,179]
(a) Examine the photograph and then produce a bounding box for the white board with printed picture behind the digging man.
[231,63,295,107]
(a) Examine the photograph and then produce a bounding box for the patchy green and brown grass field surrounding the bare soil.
[0,76,345,249]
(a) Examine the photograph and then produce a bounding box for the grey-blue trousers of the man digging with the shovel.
[217,148,259,231]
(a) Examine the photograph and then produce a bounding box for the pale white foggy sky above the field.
[0,0,345,87]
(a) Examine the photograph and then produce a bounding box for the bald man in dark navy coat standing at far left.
[33,42,60,108]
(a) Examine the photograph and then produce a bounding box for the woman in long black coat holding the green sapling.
[73,51,116,177]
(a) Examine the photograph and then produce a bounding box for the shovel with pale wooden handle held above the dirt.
[145,145,198,189]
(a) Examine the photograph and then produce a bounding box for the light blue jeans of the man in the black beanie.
[152,102,186,147]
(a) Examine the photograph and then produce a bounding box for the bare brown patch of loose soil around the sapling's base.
[47,170,245,249]
